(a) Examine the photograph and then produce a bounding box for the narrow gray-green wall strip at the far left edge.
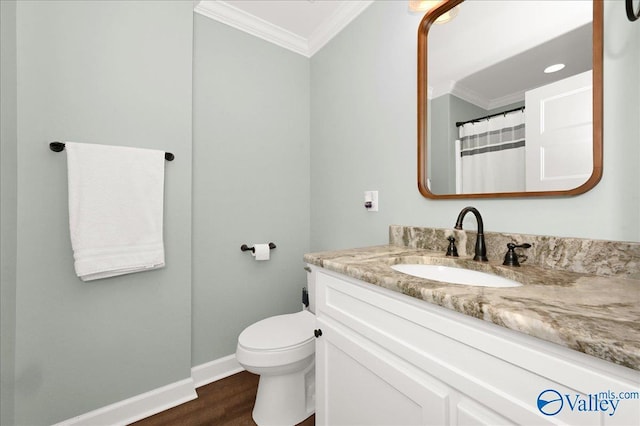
[0,1,18,425]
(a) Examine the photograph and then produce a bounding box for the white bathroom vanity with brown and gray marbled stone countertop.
[305,227,640,425]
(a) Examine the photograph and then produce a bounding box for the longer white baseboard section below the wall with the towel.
[54,378,198,426]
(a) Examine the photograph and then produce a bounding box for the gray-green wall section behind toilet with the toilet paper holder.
[193,14,309,365]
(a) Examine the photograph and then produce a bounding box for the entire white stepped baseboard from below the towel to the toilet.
[54,354,244,426]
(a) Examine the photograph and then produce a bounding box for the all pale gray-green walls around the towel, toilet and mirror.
[0,0,640,425]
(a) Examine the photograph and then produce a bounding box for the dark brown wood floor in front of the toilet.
[132,371,315,426]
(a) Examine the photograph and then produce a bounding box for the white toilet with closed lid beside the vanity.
[236,309,315,426]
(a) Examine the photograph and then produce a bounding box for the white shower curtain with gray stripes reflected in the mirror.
[456,111,525,194]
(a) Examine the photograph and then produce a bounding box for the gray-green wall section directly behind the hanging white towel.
[8,1,193,425]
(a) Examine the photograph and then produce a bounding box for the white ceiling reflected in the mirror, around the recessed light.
[428,0,593,109]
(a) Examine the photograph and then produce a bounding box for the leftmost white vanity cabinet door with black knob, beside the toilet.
[316,317,449,426]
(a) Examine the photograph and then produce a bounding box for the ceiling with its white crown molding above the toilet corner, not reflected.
[194,0,373,57]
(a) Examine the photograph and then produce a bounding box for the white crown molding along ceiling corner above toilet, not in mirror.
[194,0,373,58]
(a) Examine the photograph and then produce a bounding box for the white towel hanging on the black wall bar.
[65,142,164,281]
